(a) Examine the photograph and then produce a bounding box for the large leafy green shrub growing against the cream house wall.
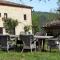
[3,18,18,34]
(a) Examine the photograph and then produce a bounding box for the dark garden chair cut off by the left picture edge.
[0,35,10,51]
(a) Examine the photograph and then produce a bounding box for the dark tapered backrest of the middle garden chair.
[20,35,33,46]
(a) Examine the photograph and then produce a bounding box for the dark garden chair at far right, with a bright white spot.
[48,38,59,52]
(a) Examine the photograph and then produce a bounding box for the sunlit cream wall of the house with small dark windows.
[0,2,32,35]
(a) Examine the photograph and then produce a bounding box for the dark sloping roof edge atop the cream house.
[0,0,32,9]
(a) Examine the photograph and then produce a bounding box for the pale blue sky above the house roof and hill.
[8,0,58,12]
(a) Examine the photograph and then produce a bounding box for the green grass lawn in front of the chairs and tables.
[0,51,60,60]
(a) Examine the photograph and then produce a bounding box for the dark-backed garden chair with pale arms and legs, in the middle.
[20,35,36,52]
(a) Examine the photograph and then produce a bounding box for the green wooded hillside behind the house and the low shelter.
[32,11,58,33]
